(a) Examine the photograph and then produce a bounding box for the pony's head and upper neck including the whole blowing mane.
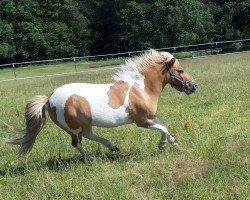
[113,50,197,95]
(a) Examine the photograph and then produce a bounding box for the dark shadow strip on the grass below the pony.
[0,151,140,176]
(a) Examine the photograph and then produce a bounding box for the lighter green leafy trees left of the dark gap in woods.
[0,0,90,62]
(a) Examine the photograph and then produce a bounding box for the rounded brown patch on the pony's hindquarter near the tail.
[64,95,92,130]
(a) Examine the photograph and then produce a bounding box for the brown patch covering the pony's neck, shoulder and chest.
[126,62,166,128]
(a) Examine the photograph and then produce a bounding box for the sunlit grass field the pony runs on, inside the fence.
[0,53,250,200]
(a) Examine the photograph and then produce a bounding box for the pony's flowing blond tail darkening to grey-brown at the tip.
[5,96,49,155]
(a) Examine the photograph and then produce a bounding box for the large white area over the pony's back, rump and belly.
[50,83,130,133]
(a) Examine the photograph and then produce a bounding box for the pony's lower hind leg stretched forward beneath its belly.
[82,127,119,151]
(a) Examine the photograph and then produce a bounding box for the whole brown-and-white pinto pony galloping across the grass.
[6,50,197,155]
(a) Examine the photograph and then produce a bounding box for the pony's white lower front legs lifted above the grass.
[148,117,178,149]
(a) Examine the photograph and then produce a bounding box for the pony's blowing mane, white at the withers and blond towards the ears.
[113,50,173,81]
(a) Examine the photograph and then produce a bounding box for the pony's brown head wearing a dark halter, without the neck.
[162,52,197,94]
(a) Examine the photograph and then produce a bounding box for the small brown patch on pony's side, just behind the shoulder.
[108,81,129,109]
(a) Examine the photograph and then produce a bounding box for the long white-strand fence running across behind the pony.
[0,39,250,82]
